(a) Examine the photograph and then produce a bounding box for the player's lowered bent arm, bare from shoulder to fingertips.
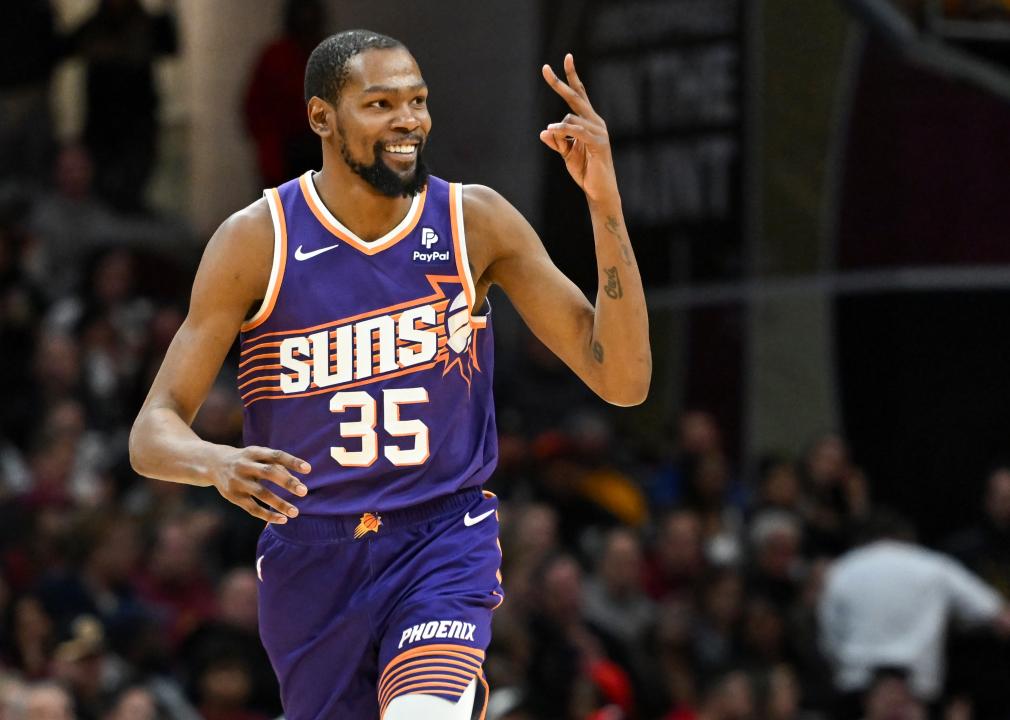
[129,200,309,523]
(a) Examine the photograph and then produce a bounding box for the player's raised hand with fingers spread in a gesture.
[540,53,617,203]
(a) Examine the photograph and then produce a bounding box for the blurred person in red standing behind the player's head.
[243,0,327,188]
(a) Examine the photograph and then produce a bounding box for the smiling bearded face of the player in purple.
[336,47,431,197]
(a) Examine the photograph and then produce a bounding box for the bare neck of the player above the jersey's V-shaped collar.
[312,163,413,241]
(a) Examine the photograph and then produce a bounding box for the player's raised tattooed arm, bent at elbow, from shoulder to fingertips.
[464,55,652,405]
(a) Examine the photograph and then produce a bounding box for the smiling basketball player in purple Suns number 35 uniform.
[130,30,651,720]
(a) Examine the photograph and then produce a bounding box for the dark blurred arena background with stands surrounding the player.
[0,0,1010,720]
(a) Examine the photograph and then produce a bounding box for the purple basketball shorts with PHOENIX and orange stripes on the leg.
[257,488,503,720]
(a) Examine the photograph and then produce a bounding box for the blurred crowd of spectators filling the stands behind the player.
[0,0,1010,720]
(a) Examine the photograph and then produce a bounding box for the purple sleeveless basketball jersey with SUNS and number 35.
[238,173,498,516]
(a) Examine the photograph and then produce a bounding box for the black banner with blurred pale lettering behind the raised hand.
[547,0,745,286]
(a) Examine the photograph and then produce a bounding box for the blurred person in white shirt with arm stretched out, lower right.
[819,513,1010,707]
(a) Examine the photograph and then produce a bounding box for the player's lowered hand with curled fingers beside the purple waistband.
[211,446,311,524]
